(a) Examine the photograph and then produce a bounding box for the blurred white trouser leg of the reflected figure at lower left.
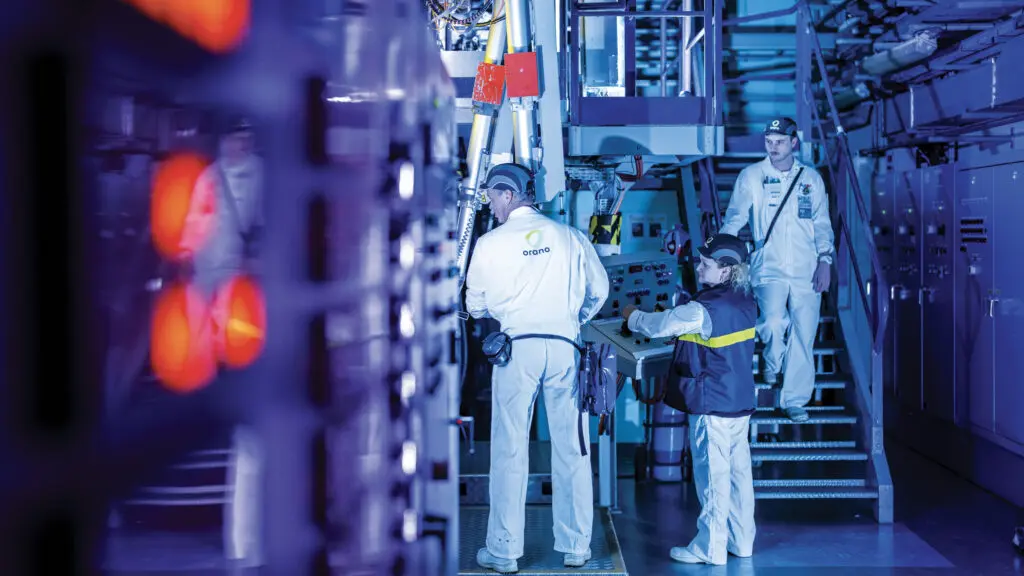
[224,425,263,566]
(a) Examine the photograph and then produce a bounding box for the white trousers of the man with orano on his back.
[486,338,594,560]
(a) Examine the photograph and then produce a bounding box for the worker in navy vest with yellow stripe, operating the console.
[623,234,757,565]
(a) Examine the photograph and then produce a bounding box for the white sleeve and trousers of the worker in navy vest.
[629,305,757,565]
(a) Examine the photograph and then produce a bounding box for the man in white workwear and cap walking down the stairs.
[720,118,835,422]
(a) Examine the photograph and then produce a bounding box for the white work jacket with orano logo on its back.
[466,207,608,339]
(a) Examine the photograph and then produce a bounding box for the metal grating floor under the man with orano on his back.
[459,506,628,576]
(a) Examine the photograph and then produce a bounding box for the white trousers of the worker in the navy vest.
[687,414,757,565]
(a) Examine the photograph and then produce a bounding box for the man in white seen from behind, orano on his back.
[466,164,608,574]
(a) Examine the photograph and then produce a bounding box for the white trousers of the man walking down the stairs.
[754,280,821,408]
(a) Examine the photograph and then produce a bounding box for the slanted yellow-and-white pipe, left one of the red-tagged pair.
[456,18,508,288]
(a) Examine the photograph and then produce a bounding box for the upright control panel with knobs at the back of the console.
[595,251,676,320]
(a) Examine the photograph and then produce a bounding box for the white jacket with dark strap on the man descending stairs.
[721,157,835,285]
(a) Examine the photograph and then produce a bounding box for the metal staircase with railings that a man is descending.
[637,0,892,523]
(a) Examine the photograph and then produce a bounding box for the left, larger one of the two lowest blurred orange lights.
[150,284,217,394]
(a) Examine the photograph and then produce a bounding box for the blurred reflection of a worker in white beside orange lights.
[182,119,263,565]
